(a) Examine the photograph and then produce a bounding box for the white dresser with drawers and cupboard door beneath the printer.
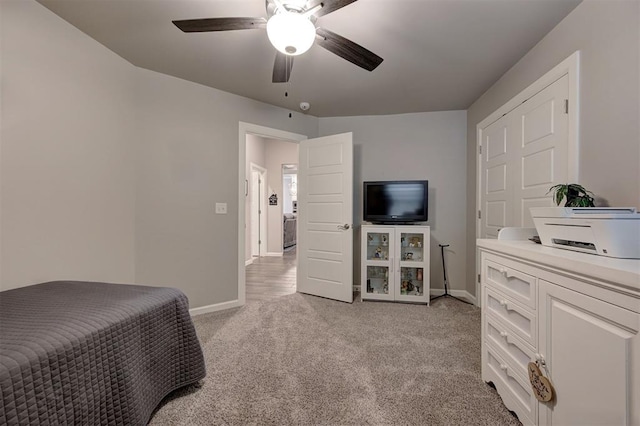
[478,239,640,426]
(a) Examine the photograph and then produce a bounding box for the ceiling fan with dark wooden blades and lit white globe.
[172,0,383,83]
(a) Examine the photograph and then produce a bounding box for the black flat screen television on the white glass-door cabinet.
[363,180,429,223]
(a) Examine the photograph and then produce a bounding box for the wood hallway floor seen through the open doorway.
[245,247,296,302]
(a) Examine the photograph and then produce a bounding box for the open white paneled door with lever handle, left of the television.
[297,133,353,303]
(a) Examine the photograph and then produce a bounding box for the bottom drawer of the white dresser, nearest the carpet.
[482,345,538,425]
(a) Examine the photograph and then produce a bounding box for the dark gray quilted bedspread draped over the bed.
[0,281,205,425]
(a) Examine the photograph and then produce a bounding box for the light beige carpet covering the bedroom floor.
[150,294,519,425]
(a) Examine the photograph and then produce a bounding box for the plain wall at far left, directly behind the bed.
[0,0,137,290]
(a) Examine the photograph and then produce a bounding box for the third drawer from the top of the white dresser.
[484,314,535,380]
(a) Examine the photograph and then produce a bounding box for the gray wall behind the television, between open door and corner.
[319,111,467,296]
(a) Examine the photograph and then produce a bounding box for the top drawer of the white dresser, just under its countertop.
[482,259,537,310]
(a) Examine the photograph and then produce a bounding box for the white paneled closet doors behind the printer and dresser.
[479,75,569,238]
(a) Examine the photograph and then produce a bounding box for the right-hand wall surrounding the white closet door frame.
[467,0,640,292]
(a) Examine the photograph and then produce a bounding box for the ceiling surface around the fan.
[38,0,581,117]
